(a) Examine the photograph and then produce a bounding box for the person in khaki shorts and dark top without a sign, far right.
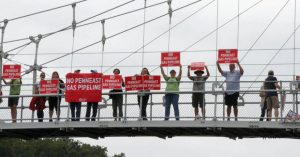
[265,70,280,121]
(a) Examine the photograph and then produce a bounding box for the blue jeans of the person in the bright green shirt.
[165,94,179,120]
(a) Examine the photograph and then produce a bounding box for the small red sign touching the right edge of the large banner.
[102,75,122,89]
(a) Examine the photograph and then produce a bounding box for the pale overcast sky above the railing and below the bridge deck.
[0,0,300,157]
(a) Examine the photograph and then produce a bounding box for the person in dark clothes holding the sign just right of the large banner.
[110,68,125,121]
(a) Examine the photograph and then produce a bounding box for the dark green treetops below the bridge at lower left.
[0,138,125,157]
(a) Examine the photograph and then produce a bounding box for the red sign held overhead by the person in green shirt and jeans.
[161,52,180,67]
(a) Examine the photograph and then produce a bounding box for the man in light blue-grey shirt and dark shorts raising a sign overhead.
[217,61,244,121]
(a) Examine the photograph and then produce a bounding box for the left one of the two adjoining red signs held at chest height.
[125,76,143,91]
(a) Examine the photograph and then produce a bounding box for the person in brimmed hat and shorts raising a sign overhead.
[188,66,210,120]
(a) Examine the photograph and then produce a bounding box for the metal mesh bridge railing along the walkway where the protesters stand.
[0,81,300,123]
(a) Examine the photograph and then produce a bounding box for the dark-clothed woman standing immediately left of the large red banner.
[48,71,65,122]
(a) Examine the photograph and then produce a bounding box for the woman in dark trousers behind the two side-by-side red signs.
[137,68,150,120]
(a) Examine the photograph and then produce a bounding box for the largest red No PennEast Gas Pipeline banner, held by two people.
[65,73,102,102]
